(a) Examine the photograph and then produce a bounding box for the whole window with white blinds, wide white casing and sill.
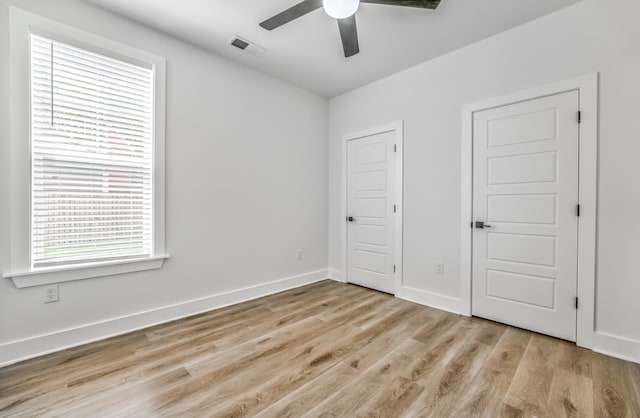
[5,8,167,287]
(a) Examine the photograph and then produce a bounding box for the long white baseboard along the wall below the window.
[0,270,328,367]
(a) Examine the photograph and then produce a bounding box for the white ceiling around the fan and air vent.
[87,0,580,97]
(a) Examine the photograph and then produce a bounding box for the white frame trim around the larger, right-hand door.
[460,73,598,348]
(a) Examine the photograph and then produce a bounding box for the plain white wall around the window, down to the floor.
[0,0,328,364]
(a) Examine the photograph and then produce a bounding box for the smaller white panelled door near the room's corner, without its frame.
[345,131,396,293]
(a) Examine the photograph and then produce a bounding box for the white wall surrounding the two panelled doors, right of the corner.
[329,0,640,361]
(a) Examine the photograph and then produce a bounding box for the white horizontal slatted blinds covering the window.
[31,35,154,268]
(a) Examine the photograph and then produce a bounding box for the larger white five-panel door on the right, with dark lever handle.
[472,91,579,341]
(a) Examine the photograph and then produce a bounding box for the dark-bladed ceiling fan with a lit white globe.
[260,0,440,58]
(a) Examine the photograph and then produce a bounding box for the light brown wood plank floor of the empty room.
[0,281,640,418]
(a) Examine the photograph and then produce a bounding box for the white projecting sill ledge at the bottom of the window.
[3,255,169,288]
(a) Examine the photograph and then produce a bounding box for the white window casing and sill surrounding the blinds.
[3,6,168,288]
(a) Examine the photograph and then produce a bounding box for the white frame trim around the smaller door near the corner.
[340,120,404,295]
